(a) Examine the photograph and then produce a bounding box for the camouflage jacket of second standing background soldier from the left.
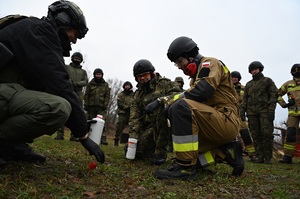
[83,78,110,110]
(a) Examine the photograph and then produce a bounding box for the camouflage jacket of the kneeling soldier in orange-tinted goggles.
[129,73,180,135]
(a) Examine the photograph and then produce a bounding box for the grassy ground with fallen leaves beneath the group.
[0,133,300,199]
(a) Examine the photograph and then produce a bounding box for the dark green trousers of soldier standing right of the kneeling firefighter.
[247,113,274,160]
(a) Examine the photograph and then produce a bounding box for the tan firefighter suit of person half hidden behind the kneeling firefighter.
[234,82,255,157]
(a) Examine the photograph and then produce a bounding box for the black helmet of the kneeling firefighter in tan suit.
[167,37,199,62]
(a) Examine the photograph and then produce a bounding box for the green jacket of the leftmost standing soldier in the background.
[66,63,88,93]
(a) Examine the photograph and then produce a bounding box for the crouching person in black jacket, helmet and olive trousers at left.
[0,1,105,166]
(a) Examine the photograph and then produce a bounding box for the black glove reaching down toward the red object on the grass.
[80,137,105,163]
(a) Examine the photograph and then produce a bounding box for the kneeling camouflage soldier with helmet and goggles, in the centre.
[129,59,180,165]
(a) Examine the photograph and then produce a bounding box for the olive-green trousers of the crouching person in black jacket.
[0,83,71,146]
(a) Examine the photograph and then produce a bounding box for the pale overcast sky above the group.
[0,0,300,122]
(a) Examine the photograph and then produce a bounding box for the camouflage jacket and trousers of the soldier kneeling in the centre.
[129,73,180,158]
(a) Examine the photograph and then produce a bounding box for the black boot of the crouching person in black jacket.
[0,143,46,163]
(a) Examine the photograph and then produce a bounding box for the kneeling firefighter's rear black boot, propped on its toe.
[221,141,245,176]
